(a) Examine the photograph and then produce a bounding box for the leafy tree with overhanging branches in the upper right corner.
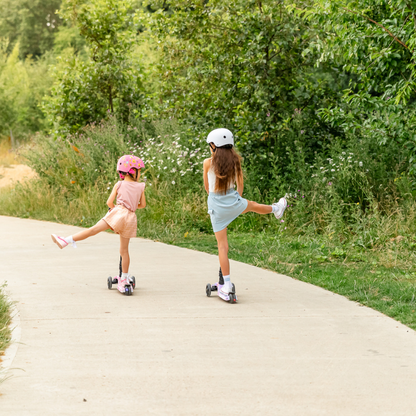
[298,0,416,179]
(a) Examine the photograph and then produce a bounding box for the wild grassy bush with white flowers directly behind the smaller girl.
[19,116,214,232]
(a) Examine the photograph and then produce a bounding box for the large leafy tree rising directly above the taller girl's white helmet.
[143,0,348,188]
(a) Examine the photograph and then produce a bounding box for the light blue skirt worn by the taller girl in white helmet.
[208,189,248,233]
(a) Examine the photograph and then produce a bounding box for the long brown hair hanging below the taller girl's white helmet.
[212,147,243,195]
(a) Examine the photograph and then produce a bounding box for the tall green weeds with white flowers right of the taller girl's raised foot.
[282,132,413,239]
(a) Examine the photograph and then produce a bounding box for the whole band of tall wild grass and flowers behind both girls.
[0,117,415,244]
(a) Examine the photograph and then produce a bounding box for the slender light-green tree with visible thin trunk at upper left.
[44,0,142,135]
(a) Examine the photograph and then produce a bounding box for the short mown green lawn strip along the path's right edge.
[146,232,416,330]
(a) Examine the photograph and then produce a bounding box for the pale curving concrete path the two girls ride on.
[0,217,416,416]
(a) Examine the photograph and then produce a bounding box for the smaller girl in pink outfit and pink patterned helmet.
[52,155,146,282]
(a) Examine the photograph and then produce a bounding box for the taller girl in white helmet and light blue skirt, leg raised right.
[204,129,287,300]
